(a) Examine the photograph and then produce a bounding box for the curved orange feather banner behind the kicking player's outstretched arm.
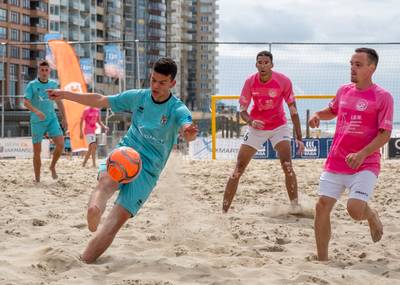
[48,40,87,151]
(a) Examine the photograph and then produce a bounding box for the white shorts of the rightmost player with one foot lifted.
[318,170,378,202]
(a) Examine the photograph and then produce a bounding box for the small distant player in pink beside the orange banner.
[80,107,108,167]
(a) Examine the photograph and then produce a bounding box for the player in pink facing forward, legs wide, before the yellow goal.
[222,51,304,212]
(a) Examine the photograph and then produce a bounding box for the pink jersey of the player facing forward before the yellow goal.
[239,71,294,130]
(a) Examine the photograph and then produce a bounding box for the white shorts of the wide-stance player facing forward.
[242,124,291,150]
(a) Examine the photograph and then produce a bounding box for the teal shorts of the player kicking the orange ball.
[99,160,158,216]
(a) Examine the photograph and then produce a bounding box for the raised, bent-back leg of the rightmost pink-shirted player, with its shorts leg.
[347,170,383,242]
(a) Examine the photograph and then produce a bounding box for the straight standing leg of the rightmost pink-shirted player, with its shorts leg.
[314,172,345,261]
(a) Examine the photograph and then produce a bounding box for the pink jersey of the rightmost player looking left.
[325,83,393,176]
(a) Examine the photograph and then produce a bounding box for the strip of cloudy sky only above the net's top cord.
[217,0,400,42]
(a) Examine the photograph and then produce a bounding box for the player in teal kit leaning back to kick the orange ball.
[48,58,198,263]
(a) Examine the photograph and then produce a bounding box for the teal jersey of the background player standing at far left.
[24,79,58,123]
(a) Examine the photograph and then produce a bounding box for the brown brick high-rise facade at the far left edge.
[0,0,48,109]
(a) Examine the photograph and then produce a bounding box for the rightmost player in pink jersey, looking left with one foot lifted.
[309,48,393,260]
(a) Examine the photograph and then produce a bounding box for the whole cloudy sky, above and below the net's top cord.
[217,0,400,125]
